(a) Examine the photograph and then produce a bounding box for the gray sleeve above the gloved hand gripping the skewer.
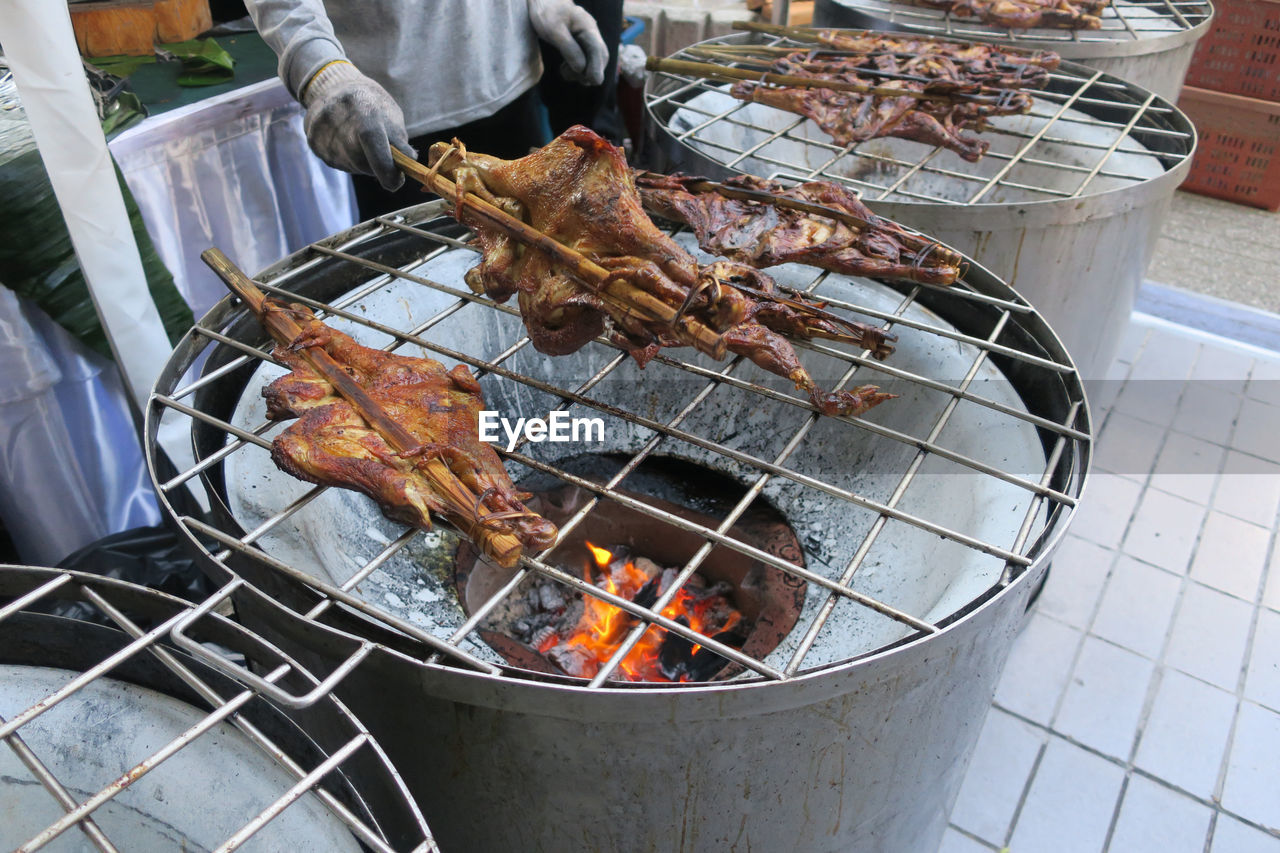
[244,0,346,97]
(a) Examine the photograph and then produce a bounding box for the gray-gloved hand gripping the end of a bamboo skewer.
[302,61,417,190]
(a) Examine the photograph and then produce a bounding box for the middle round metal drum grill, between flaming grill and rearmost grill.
[645,35,1196,377]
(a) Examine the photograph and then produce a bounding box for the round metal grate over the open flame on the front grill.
[147,195,1091,689]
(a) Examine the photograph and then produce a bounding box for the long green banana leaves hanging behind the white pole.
[0,117,193,359]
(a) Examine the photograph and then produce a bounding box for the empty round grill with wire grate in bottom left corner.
[0,566,435,853]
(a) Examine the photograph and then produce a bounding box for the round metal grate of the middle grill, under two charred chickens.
[646,35,1196,205]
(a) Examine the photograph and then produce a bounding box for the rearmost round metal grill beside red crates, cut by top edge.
[813,0,1213,101]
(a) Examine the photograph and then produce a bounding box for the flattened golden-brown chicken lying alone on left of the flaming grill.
[262,301,557,561]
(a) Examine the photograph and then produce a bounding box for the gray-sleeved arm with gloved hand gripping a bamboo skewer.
[244,0,416,190]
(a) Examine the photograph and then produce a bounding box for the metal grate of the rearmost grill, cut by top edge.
[819,0,1213,43]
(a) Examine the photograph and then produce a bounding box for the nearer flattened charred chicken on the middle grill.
[730,55,1032,161]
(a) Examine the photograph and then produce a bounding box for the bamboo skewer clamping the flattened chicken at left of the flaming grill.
[200,242,524,569]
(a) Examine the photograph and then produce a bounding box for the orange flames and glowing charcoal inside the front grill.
[538,542,744,681]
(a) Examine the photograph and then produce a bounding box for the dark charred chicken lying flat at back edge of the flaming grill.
[636,172,961,284]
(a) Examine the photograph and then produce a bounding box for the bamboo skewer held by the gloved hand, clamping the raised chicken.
[392,147,727,359]
